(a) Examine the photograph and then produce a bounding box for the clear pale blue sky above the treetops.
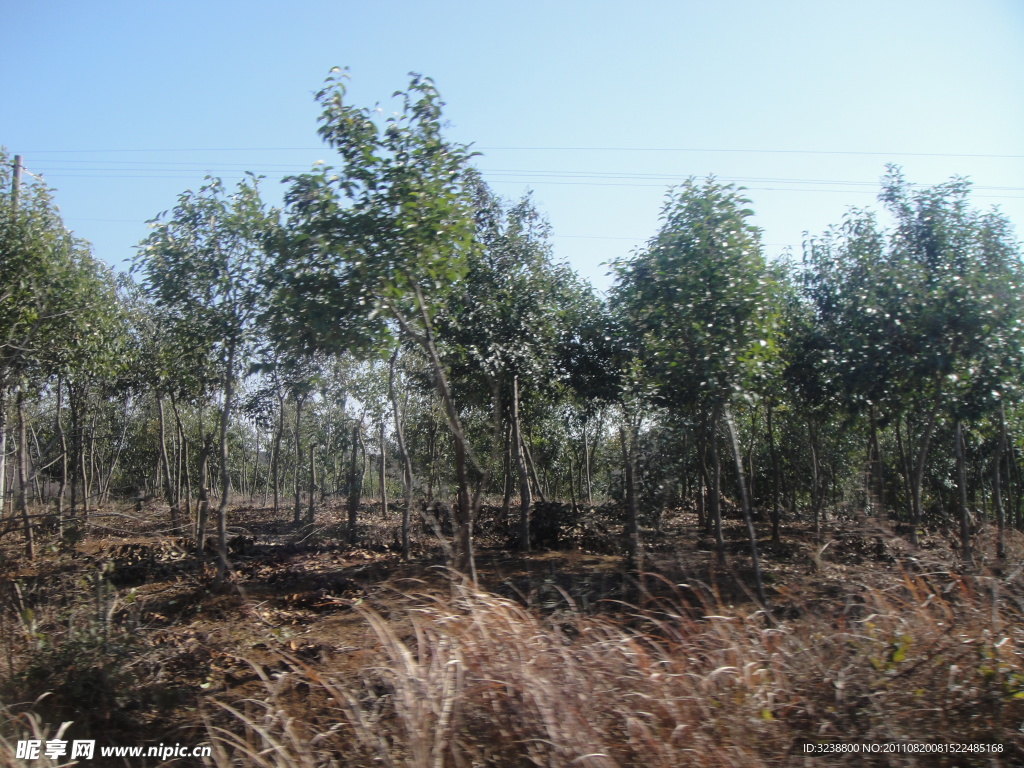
[0,0,1024,288]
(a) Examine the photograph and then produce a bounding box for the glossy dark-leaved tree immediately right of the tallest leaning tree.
[437,179,591,551]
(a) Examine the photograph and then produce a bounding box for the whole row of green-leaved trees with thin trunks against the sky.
[0,71,1024,579]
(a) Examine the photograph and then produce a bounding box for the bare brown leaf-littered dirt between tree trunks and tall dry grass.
[0,503,1024,766]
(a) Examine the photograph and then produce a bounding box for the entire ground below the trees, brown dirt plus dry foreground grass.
[0,503,1024,768]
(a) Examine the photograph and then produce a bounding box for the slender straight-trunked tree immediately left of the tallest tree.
[133,176,278,587]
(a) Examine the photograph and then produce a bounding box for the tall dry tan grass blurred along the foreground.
[208,573,1024,768]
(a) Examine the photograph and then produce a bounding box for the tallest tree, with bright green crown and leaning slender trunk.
[274,69,473,571]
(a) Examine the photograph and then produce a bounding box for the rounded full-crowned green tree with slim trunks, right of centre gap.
[614,178,772,601]
